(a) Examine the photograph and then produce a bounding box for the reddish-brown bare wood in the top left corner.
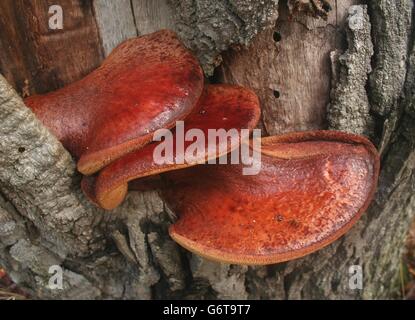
[0,0,102,95]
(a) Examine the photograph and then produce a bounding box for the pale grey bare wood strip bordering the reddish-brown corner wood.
[93,0,138,56]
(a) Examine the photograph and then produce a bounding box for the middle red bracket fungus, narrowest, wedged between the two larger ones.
[82,85,260,209]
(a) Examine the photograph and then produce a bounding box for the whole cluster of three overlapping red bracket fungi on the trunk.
[25,30,379,264]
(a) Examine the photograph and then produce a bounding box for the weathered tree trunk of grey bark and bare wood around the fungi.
[0,0,415,299]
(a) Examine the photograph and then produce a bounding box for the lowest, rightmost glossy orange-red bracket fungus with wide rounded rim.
[164,131,379,264]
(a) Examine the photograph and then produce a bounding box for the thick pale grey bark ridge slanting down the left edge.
[0,77,104,255]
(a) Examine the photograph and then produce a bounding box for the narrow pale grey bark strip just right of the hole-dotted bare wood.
[327,6,374,136]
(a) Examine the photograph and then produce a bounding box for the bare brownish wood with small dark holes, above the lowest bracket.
[218,0,356,135]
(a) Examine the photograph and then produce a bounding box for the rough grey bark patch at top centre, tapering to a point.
[170,0,278,75]
